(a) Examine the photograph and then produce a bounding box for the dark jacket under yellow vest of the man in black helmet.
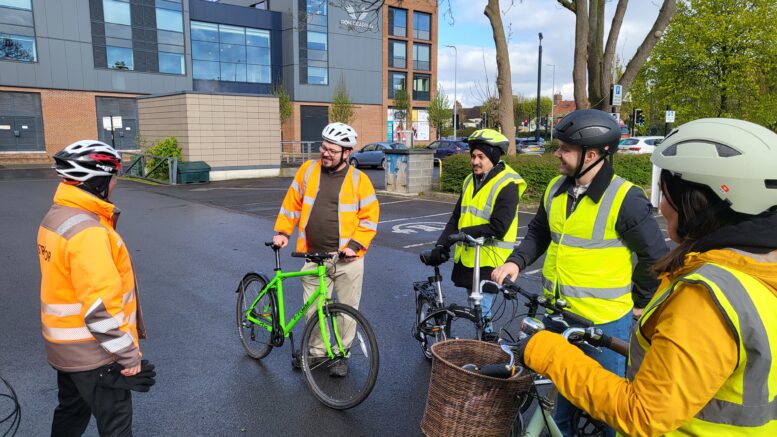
[507,162,669,308]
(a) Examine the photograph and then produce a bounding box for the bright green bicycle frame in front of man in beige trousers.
[246,264,345,359]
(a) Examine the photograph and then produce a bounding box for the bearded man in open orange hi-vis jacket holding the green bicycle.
[273,123,380,376]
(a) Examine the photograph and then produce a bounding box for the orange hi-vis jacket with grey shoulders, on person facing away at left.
[38,183,145,372]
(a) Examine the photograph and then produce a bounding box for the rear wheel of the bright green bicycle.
[237,275,277,359]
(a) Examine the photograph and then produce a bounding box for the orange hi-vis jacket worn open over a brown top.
[275,160,380,256]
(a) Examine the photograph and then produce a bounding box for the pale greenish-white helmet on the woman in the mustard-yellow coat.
[651,118,777,215]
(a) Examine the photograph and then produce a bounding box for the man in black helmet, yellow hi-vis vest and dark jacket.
[492,109,668,436]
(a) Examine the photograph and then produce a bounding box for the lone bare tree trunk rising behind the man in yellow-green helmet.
[483,0,516,155]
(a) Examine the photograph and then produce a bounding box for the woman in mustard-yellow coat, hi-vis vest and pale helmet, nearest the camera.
[500,118,777,436]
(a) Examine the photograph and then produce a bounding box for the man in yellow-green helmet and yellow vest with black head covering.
[431,129,526,333]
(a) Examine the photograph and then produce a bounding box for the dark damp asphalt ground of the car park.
[0,165,668,436]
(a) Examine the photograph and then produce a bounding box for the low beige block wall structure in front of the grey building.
[138,93,281,180]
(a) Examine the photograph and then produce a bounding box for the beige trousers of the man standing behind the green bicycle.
[301,257,364,356]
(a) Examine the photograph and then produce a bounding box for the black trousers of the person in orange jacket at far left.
[51,368,132,437]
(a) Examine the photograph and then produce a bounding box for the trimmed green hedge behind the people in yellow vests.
[441,153,652,202]
